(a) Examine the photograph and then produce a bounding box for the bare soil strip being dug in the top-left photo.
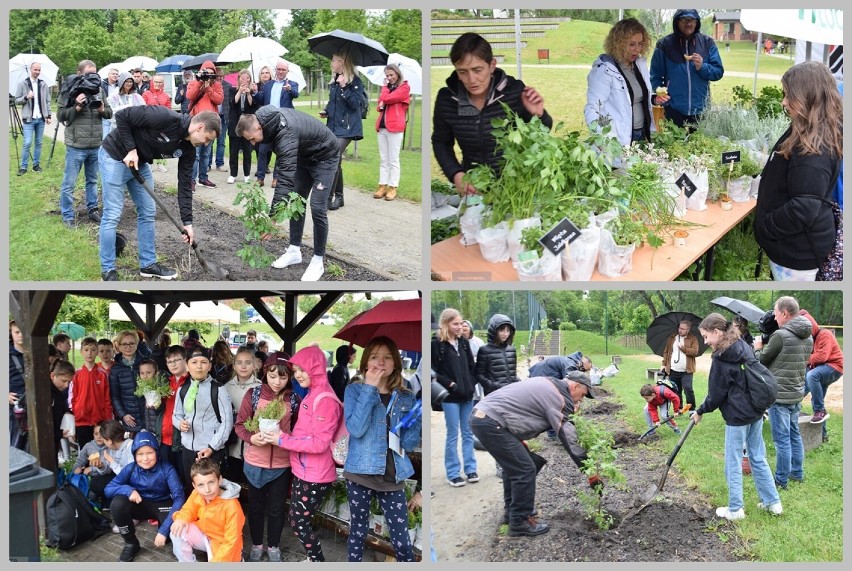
[110,189,389,281]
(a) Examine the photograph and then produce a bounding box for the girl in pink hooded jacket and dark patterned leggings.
[262,346,343,561]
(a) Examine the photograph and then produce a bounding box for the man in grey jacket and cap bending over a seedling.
[470,371,604,536]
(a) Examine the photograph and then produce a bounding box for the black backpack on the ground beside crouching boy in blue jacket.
[45,482,110,549]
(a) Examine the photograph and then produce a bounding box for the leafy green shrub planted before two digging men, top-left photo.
[234,183,306,268]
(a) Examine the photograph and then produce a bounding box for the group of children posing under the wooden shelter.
[51,330,420,562]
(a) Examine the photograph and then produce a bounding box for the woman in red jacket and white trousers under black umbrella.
[373,63,411,200]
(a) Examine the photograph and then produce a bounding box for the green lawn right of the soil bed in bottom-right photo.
[604,357,843,562]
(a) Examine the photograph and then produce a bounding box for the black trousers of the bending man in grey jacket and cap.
[470,415,536,526]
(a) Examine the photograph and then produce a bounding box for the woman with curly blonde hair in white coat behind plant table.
[583,18,668,147]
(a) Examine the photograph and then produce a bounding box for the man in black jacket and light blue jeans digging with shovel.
[98,106,222,281]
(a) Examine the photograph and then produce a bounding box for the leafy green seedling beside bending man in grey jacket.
[572,414,625,531]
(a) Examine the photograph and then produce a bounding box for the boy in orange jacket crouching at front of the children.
[170,458,246,563]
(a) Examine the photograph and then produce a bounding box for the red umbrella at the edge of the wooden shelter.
[333,298,423,351]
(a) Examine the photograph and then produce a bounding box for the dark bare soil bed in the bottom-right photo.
[460,387,748,562]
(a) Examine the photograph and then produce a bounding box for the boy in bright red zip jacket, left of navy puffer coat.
[68,337,113,446]
